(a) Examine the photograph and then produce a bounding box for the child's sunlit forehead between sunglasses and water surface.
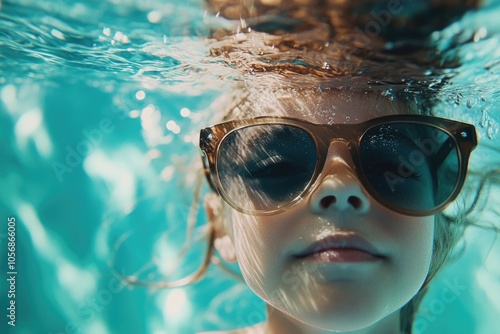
[232,89,411,124]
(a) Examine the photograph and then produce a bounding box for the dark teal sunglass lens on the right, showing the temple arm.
[359,123,459,211]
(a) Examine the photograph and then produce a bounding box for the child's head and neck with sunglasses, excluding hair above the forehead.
[194,84,476,333]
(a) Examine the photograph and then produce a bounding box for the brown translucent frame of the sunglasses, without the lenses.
[200,114,477,216]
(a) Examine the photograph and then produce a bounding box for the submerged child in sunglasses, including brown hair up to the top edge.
[136,1,496,334]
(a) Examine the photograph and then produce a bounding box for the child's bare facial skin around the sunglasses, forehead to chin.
[219,90,434,331]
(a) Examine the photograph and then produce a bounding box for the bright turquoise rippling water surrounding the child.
[0,0,500,334]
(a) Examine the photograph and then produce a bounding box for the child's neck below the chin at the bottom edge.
[261,305,401,334]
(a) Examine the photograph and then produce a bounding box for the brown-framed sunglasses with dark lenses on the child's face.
[200,115,477,216]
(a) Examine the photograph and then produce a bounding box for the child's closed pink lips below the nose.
[295,234,385,262]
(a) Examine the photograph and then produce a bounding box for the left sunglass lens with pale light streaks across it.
[217,124,317,211]
